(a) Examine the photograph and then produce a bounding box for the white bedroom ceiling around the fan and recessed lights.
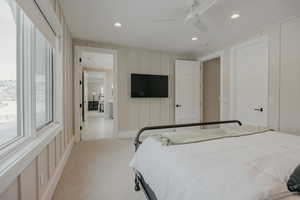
[61,0,300,53]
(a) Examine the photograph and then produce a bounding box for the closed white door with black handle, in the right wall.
[232,37,268,126]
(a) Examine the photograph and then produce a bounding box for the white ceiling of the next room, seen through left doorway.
[81,51,114,70]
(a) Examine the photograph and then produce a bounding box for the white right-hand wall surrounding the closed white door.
[200,18,300,133]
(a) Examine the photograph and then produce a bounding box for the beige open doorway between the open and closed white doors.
[202,57,221,122]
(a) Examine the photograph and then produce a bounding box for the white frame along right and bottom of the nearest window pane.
[0,4,32,160]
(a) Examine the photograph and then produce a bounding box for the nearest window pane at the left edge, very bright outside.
[0,0,20,145]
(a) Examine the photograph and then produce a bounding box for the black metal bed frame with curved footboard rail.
[134,120,242,200]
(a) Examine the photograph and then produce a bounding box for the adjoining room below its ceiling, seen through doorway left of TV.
[82,68,113,140]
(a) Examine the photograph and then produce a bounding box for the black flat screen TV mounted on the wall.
[131,74,169,98]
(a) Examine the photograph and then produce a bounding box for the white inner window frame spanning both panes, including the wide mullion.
[0,3,56,158]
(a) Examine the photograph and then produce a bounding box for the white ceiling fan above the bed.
[152,0,219,32]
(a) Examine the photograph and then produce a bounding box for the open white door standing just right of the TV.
[175,60,201,124]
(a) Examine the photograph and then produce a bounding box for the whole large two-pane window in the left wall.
[0,0,54,149]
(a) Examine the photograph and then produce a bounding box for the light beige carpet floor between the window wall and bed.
[52,139,145,200]
